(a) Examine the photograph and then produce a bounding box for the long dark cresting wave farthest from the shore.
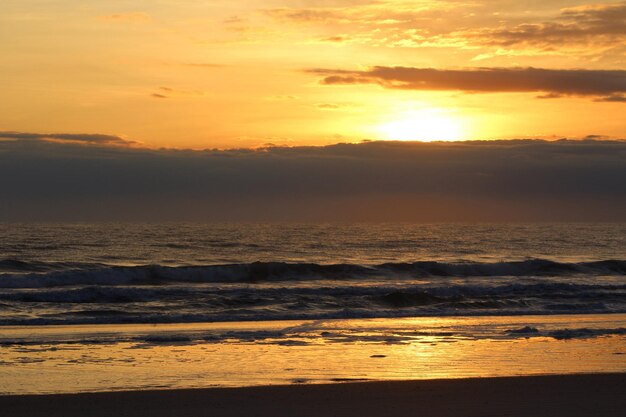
[0,259,626,288]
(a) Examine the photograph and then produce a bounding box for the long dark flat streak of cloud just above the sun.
[308,67,626,101]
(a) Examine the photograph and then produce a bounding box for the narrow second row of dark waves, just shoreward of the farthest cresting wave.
[0,283,626,309]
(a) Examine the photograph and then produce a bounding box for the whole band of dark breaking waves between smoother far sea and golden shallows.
[0,259,626,325]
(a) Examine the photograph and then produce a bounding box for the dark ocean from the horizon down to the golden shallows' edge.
[0,224,626,325]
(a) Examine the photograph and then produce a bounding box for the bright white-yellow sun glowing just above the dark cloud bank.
[378,109,464,142]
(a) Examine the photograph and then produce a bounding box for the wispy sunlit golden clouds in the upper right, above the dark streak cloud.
[263,0,626,60]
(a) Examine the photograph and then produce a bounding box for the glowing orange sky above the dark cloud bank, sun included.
[0,0,626,149]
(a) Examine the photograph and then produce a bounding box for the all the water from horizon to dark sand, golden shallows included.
[0,223,626,394]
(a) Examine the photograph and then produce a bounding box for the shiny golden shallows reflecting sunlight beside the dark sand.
[0,315,626,393]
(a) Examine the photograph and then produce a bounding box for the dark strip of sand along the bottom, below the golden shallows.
[0,373,626,417]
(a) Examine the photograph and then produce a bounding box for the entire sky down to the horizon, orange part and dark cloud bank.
[0,0,626,222]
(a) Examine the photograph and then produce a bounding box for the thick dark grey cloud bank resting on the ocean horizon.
[0,134,626,221]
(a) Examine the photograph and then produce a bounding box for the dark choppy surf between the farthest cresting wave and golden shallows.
[0,280,626,325]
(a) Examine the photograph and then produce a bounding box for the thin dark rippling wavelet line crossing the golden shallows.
[0,321,626,350]
